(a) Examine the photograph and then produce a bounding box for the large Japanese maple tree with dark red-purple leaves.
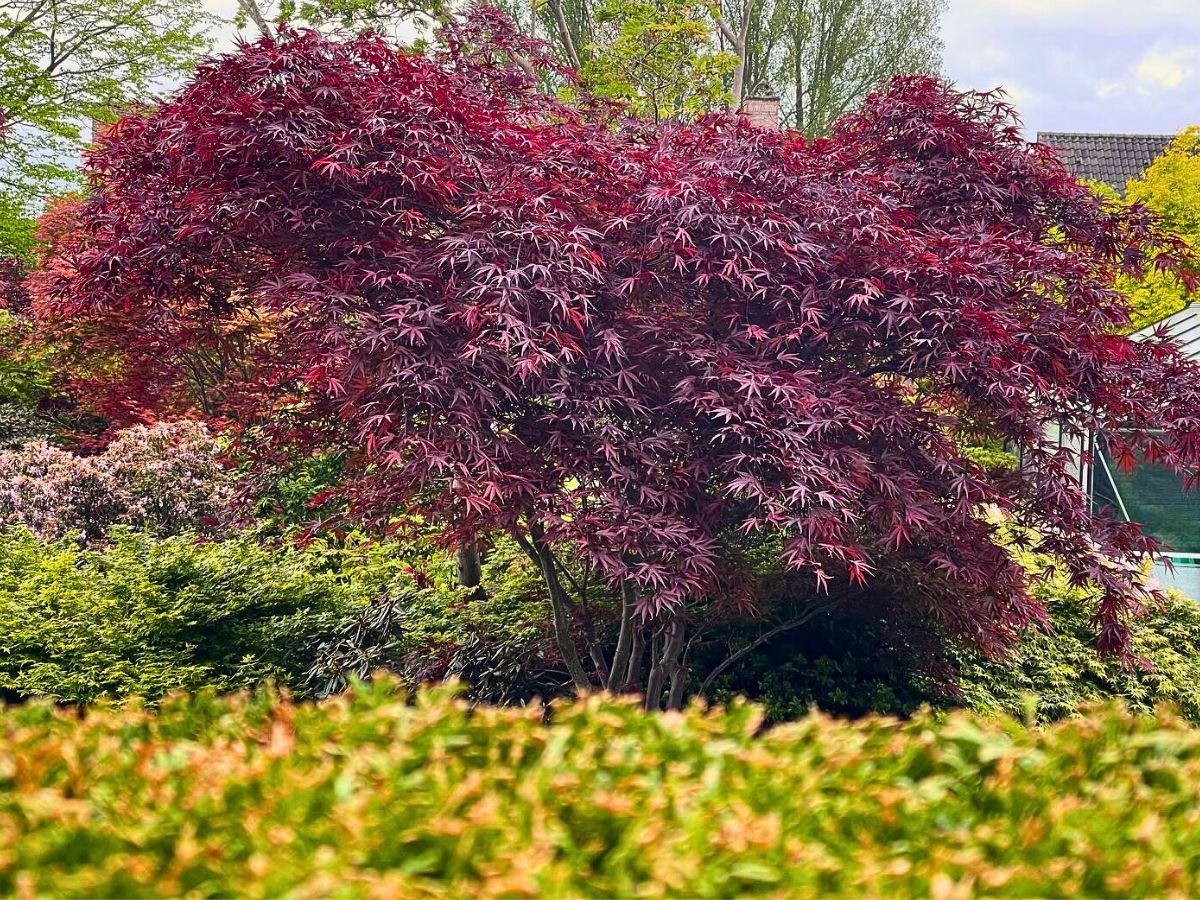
[38,10,1200,706]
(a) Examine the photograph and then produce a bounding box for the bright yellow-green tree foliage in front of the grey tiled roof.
[1104,126,1200,328]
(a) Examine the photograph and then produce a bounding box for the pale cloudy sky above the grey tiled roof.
[205,0,1200,137]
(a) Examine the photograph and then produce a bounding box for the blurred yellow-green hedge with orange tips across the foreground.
[0,684,1200,896]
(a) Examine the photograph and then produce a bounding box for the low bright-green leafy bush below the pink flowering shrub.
[0,529,401,702]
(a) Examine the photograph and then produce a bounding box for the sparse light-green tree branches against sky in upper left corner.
[0,0,206,217]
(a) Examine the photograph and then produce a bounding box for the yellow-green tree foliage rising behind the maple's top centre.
[580,0,737,122]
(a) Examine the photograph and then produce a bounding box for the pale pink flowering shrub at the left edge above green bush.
[0,420,230,542]
